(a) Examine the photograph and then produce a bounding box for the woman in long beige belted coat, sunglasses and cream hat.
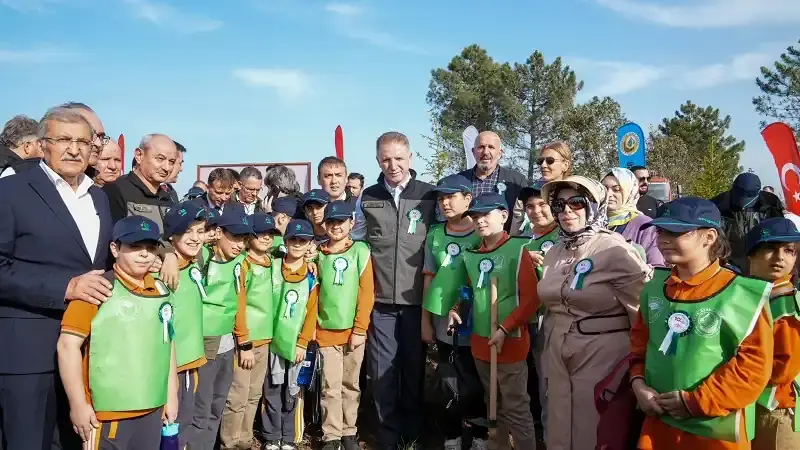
[538,176,652,450]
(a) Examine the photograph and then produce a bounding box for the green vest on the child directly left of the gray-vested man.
[317,241,370,330]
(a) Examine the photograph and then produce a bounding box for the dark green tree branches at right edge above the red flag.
[753,41,800,132]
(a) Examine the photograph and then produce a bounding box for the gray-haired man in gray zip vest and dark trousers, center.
[351,132,436,450]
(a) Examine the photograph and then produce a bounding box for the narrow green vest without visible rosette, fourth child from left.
[246,262,280,341]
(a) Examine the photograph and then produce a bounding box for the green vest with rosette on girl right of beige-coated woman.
[639,268,772,442]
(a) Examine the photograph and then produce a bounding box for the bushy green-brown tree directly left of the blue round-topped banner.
[556,97,626,180]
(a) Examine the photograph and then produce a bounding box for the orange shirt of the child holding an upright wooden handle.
[456,232,541,364]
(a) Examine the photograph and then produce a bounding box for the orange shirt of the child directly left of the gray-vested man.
[305,239,375,347]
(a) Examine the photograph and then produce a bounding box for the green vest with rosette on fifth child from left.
[269,260,317,361]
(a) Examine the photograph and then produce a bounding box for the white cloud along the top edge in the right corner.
[595,0,800,28]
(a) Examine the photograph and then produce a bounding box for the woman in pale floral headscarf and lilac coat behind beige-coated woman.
[602,167,664,266]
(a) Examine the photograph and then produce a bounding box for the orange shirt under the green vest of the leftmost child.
[61,264,162,422]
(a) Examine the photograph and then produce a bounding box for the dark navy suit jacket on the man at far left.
[0,167,113,374]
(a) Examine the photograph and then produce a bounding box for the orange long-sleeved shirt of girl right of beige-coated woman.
[630,261,772,450]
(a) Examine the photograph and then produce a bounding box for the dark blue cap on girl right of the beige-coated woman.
[642,197,722,233]
